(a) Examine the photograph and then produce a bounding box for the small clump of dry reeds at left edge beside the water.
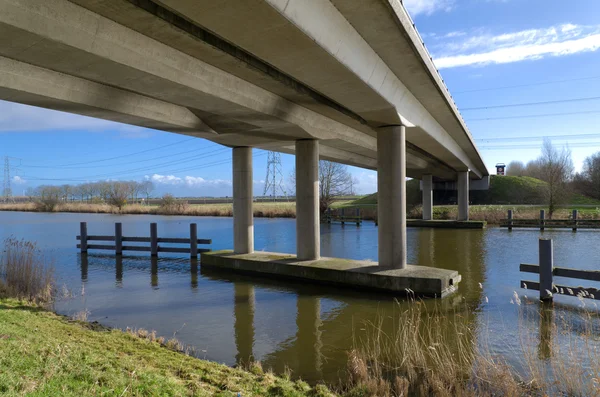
[0,238,54,303]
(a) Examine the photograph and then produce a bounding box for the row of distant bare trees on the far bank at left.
[25,181,154,211]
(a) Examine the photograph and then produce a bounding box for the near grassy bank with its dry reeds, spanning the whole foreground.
[0,240,600,397]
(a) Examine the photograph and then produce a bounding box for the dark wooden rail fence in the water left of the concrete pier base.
[75,222,212,258]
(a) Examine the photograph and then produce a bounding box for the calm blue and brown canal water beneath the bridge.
[0,212,600,382]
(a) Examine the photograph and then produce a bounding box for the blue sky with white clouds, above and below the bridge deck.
[0,0,600,196]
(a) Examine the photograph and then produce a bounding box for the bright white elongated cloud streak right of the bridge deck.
[430,24,600,69]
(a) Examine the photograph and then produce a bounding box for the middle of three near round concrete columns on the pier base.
[296,139,321,260]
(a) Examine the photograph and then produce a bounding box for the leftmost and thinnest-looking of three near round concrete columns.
[233,147,254,254]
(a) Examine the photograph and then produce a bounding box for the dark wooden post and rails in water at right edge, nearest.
[519,239,600,300]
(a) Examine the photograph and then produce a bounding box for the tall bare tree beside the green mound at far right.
[537,139,574,218]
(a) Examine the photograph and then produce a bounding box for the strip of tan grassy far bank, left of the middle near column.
[0,202,296,218]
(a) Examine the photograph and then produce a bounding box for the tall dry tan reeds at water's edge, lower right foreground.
[341,301,600,397]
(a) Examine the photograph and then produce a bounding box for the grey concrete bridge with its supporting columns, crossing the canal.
[0,0,488,284]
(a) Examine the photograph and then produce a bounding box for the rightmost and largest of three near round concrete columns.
[377,126,406,269]
